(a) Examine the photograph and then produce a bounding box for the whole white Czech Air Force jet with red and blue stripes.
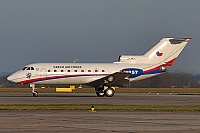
[7,38,192,97]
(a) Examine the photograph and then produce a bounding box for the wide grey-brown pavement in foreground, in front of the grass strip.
[0,111,200,133]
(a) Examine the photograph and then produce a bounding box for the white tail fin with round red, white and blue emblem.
[144,38,191,66]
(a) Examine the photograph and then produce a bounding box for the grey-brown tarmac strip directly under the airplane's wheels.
[0,92,200,105]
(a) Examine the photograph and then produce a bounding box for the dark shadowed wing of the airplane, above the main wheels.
[88,72,130,87]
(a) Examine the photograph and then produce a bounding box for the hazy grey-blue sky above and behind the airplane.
[0,0,200,73]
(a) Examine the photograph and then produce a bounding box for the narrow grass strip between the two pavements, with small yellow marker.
[0,104,200,112]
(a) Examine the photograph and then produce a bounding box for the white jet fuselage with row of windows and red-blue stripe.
[9,63,160,84]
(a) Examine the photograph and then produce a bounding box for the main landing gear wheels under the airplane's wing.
[95,86,115,97]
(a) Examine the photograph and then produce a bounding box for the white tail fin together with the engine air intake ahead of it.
[118,38,192,66]
